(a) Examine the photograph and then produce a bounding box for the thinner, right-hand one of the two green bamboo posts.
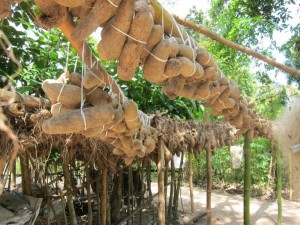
[275,144,282,225]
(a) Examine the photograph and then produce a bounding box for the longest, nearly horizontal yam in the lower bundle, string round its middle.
[42,105,114,134]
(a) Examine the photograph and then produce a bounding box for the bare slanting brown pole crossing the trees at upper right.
[173,15,300,77]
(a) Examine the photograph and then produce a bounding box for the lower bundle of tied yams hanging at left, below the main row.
[42,69,157,164]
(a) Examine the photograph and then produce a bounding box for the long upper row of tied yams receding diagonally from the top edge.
[37,0,269,136]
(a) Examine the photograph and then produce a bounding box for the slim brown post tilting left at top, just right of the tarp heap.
[63,158,77,225]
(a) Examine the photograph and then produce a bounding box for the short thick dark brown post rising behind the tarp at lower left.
[20,152,32,196]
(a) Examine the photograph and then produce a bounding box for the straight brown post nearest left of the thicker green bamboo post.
[206,144,212,225]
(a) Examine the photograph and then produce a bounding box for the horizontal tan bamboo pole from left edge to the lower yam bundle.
[0,89,51,108]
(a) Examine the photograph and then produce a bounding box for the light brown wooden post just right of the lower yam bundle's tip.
[157,141,166,225]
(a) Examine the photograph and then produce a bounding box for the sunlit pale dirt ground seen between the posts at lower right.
[153,185,300,225]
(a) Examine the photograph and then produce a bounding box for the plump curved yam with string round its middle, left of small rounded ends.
[144,38,178,83]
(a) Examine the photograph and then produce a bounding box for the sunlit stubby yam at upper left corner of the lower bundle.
[42,79,85,107]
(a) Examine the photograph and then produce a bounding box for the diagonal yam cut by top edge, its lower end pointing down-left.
[72,0,122,41]
